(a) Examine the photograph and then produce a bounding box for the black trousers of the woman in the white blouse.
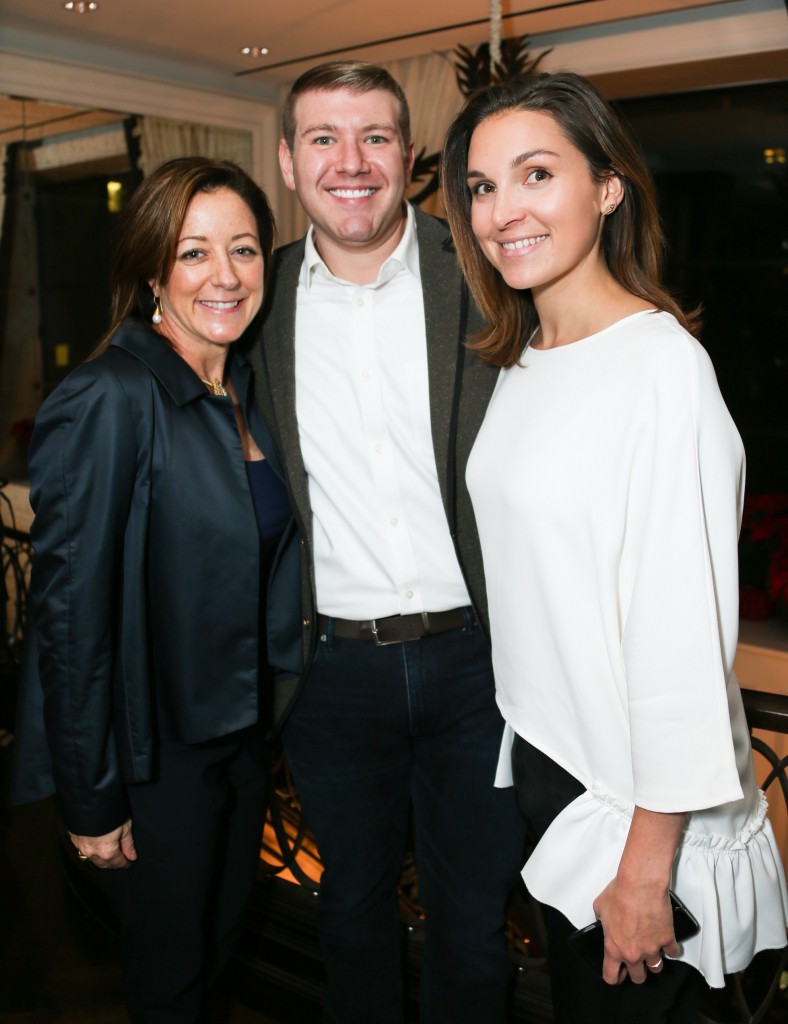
[512,736,703,1024]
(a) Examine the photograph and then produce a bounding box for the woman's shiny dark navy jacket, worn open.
[14,321,302,836]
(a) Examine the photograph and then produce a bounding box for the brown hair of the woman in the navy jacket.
[90,157,275,358]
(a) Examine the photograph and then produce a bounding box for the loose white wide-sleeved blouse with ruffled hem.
[468,311,788,986]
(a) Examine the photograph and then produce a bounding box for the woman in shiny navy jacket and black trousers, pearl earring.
[15,158,300,1024]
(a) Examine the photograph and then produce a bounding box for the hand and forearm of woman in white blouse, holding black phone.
[594,807,685,985]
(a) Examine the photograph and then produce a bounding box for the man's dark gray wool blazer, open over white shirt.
[247,208,498,725]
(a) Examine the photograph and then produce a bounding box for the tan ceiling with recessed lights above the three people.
[0,0,761,95]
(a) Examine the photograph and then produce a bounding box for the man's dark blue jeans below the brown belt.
[283,610,525,1024]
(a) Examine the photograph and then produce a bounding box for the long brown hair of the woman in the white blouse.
[441,72,699,367]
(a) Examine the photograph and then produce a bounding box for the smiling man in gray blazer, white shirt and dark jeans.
[253,61,524,1024]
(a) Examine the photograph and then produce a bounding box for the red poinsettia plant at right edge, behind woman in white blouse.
[739,495,788,618]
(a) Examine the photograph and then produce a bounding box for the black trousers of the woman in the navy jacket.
[101,728,268,1024]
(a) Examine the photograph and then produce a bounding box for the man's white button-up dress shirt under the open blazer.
[296,201,470,620]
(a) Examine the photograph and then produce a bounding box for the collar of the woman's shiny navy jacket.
[110,318,250,408]
